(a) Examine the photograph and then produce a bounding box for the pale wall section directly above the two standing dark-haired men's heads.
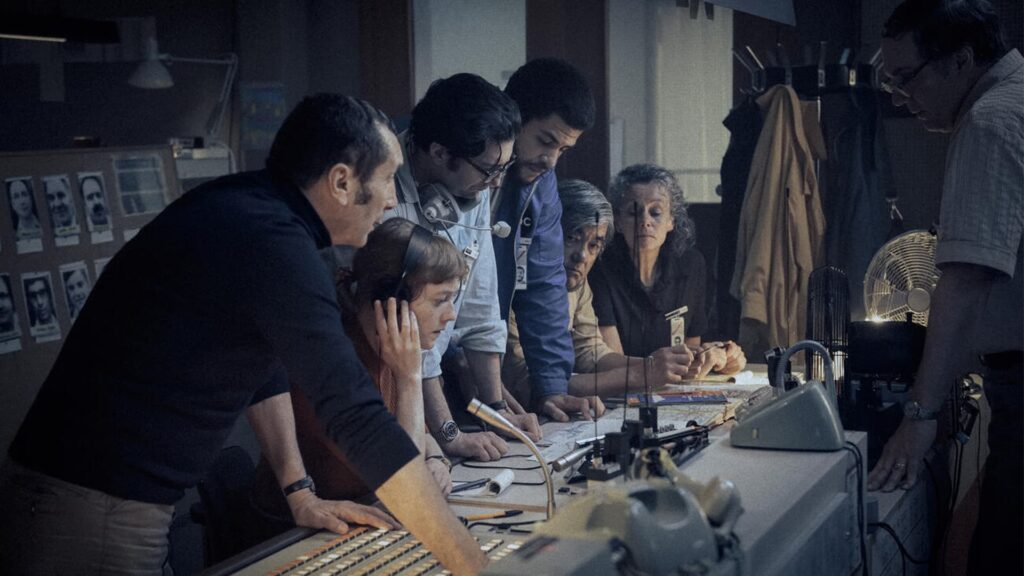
[413,0,526,101]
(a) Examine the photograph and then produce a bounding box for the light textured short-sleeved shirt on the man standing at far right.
[935,49,1024,353]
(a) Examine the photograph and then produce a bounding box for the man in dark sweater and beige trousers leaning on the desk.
[0,94,485,574]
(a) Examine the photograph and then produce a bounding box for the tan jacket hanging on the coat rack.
[730,85,825,354]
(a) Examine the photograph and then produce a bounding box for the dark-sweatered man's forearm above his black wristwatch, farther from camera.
[246,393,306,486]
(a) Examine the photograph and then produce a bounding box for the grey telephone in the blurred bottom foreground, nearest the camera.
[483,448,742,576]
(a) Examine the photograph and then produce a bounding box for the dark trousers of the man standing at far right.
[969,353,1024,574]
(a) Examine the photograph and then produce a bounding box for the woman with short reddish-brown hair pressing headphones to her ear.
[253,218,466,528]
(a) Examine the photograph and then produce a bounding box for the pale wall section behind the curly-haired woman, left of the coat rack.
[608,0,732,203]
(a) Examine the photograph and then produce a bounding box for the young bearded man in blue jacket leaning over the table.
[492,58,604,421]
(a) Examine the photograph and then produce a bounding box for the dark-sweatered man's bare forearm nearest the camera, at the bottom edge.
[376,458,487,574]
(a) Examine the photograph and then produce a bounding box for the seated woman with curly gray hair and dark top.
[590,164,746,377]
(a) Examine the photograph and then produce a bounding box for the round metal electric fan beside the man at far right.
[864,230,941,327]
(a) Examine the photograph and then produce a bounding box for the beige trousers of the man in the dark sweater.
[0,460,174,576]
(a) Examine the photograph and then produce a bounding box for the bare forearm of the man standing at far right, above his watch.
[910,264,994,410]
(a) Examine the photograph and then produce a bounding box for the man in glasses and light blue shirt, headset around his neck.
[372,74,541,460]
